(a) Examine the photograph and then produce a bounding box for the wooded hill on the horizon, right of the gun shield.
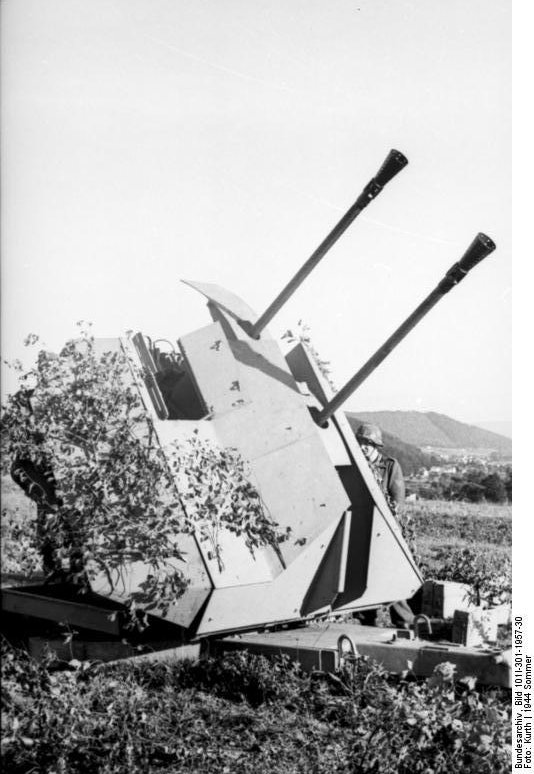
[347,411,512,454]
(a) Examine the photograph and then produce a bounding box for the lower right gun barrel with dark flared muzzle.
[314,233,496,426]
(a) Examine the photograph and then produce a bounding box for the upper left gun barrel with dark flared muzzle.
[244,150,408,339]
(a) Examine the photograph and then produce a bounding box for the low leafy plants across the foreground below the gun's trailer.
[2,649,511,774]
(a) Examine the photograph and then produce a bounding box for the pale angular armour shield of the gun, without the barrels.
[76,282,422,637]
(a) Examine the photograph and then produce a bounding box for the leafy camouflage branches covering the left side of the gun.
[1,323,287,624]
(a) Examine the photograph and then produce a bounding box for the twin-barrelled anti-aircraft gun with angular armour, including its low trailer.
[3,151,506,682]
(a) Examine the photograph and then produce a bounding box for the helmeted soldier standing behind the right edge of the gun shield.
[356,423,414,629]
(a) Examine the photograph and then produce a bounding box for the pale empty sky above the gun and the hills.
[2,0,511,422]
